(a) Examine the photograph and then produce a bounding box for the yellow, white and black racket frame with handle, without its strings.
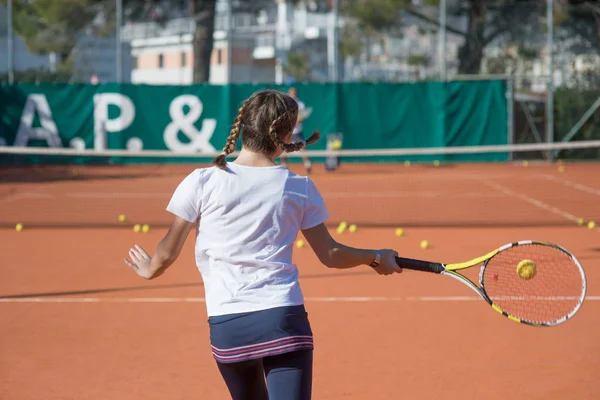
[396,240,587,326]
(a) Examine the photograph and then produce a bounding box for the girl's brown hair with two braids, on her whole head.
[213,89,320,169]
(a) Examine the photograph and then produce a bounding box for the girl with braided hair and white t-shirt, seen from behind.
[125,90,402,400]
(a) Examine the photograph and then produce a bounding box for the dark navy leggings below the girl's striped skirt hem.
[217,350,313,400]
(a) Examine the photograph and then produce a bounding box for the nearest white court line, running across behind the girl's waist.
[0,296,600,303]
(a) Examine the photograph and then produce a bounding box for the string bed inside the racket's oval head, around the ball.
[481,244,584,323]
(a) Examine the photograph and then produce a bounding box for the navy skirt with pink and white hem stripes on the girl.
[208,305,313,364]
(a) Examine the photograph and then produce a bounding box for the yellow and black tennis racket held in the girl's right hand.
[396,240,586,326]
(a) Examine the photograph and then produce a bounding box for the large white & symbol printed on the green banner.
[163,95,217,153]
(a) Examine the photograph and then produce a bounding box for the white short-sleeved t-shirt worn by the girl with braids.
[167,163,329,316]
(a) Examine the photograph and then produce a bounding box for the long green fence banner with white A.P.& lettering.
[0,81,508,163]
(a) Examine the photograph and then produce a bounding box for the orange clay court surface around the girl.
[0,164,600,400]
